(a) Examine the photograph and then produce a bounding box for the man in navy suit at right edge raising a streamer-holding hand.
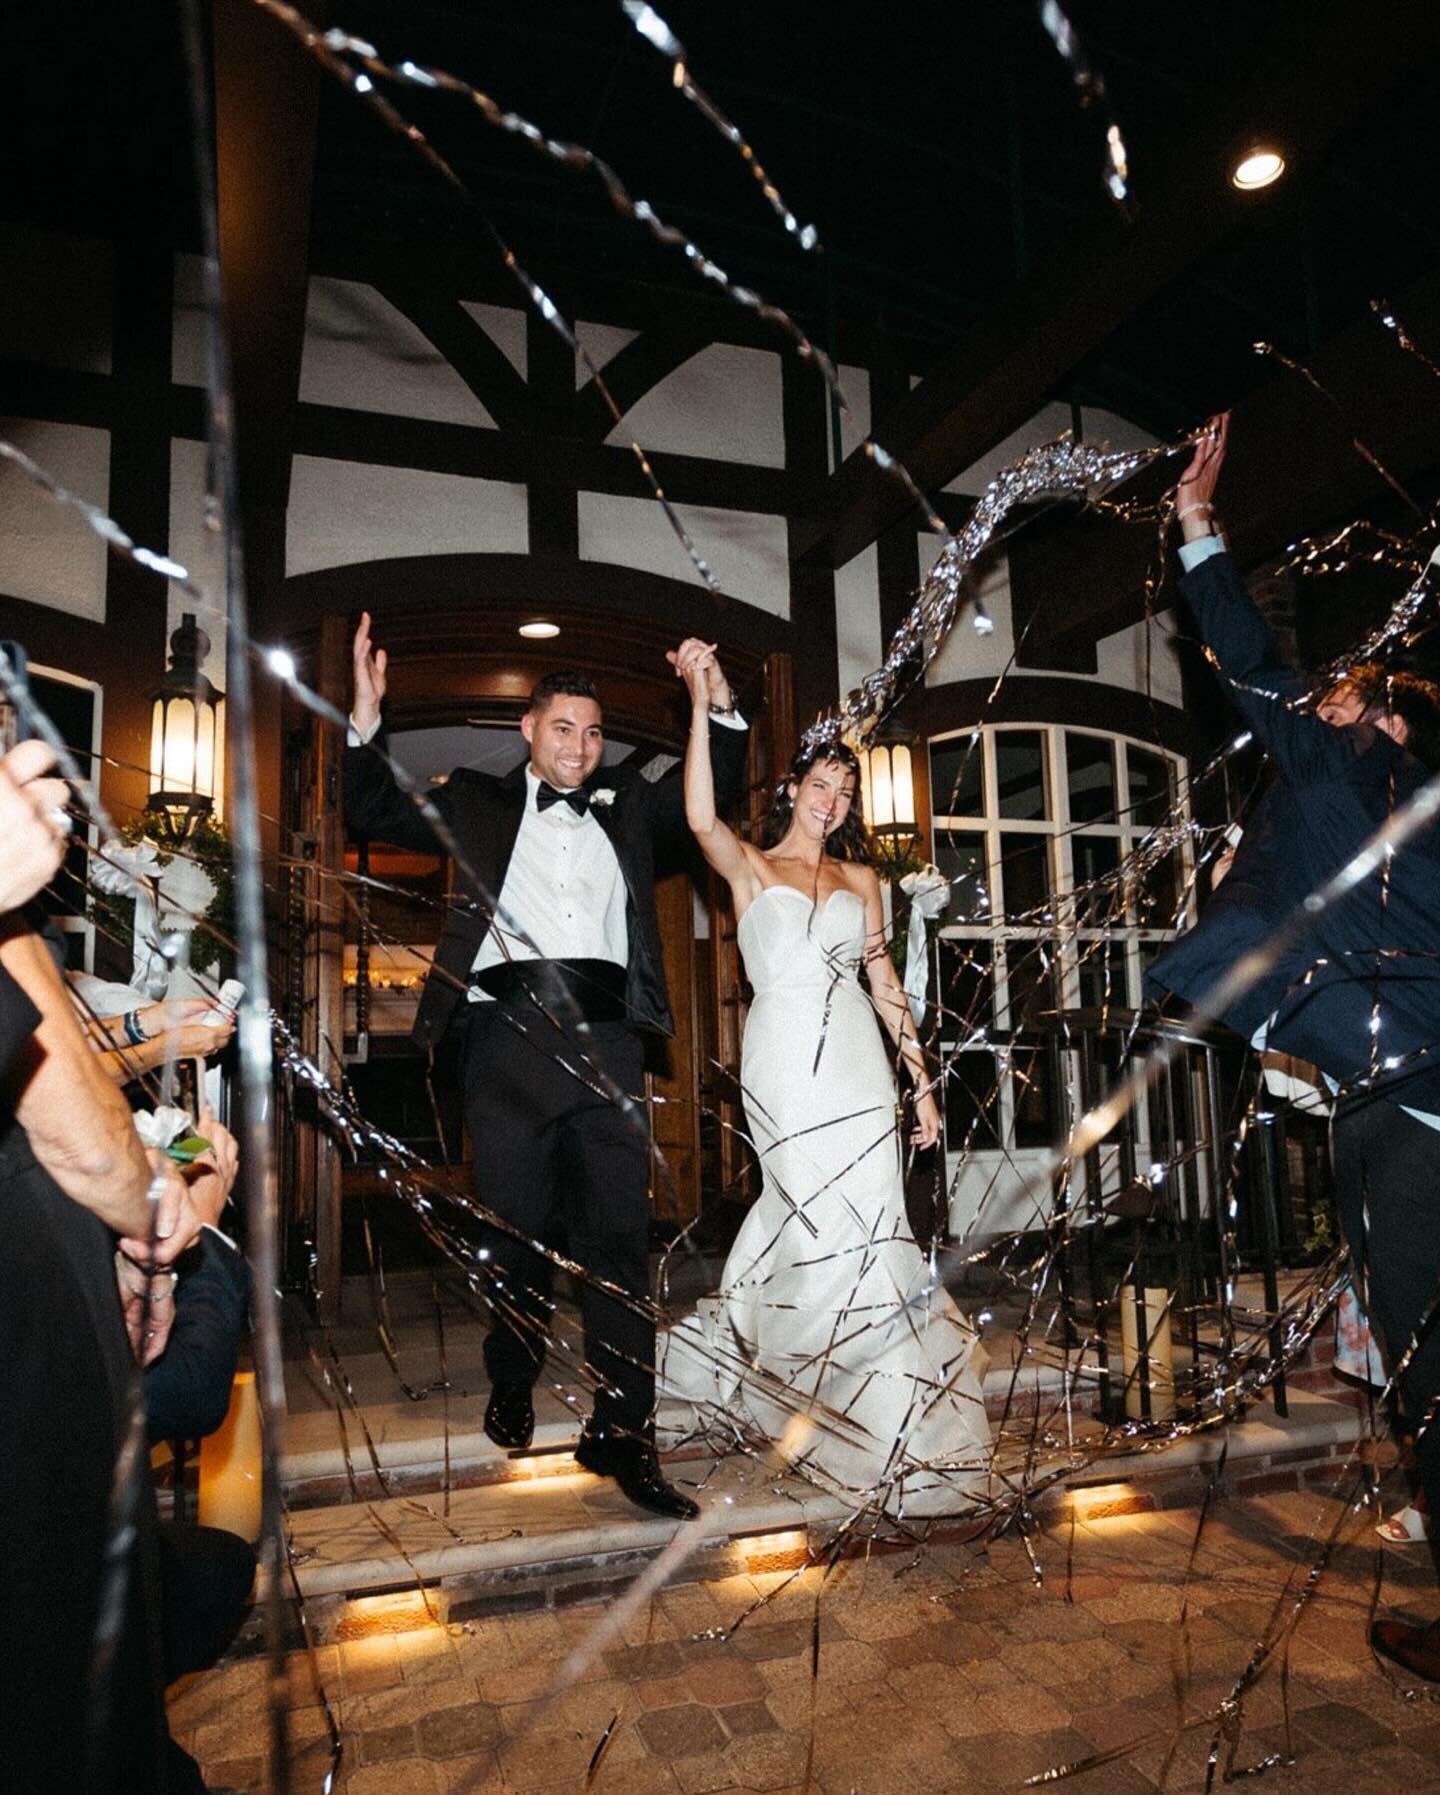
[1149,418,1440,1680]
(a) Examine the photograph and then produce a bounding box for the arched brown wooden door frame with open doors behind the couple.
[278,601,794,1318]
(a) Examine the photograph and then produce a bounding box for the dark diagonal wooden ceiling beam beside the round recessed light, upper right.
[795,0,1440,567]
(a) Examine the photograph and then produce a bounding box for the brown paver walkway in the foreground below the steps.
[171,1493,1440,1795]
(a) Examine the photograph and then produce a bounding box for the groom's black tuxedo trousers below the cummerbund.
[463,1002,655,1436]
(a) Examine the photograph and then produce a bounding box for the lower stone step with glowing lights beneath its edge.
[263,1391,1363,1639]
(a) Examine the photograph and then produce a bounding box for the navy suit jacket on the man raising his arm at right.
[1147,555,1440,1115]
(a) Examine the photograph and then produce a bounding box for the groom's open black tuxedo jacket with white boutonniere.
[345,725,751,1046]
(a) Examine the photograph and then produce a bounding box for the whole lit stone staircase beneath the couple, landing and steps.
[249,1263,1365,1641]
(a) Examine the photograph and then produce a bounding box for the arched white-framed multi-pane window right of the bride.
[930,723,1194,1154]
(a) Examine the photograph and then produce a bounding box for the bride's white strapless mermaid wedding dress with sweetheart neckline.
[657,885,989,1515]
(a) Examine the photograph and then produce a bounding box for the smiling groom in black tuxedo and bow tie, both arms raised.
[345,614,749,1519]
